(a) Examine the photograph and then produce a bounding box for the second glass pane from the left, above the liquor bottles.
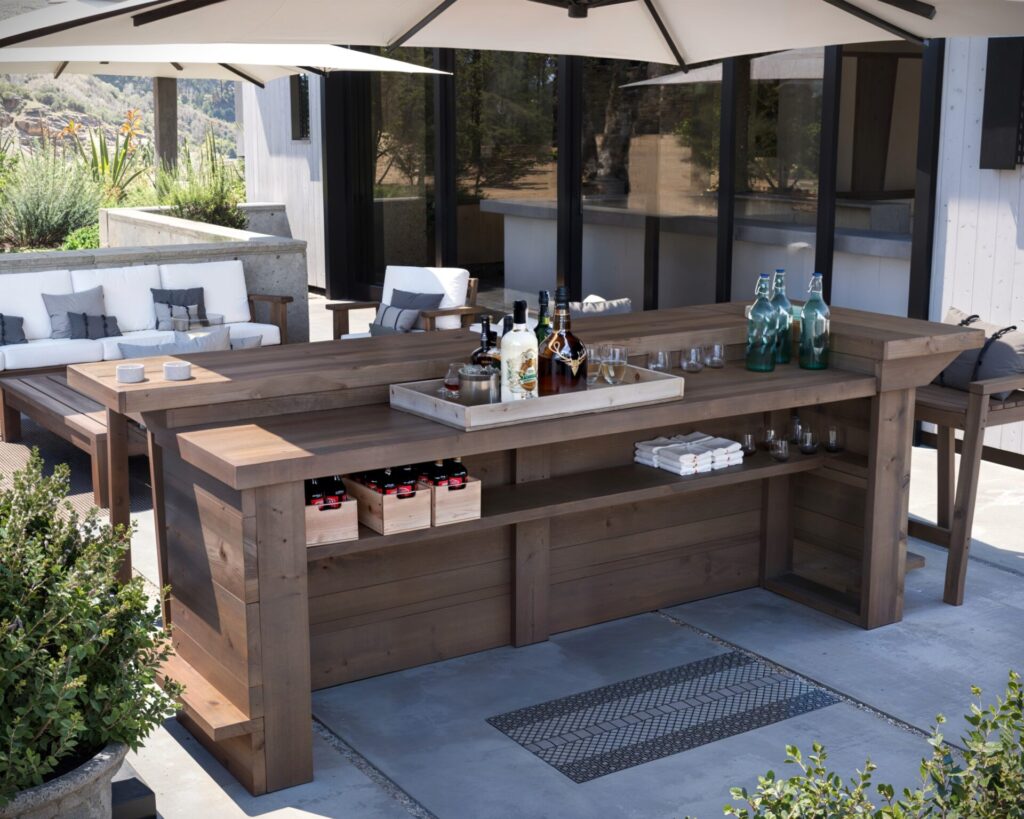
[455,50,558,311]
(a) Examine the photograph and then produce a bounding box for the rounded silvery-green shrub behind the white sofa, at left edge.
[0,144,102,248]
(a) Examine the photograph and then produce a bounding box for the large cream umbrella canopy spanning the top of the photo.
[0,0,1024,66]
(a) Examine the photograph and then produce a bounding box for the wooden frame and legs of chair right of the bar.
[907,375,1024,606]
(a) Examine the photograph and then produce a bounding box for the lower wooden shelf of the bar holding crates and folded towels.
[306,452,833,560]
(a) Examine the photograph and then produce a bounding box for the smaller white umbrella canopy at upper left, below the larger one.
[0,43,448,85]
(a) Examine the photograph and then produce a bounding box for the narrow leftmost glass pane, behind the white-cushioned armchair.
[372,48,435,284]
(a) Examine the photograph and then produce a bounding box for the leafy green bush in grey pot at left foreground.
[0,452,179,819]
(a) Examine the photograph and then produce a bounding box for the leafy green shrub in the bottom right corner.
[725,672,1024,819]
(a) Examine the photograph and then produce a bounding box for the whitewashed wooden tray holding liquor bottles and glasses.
[391,367,685,432]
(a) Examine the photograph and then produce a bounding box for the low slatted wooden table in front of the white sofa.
[0,372,147,508]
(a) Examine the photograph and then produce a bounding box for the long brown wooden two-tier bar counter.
[69,304,983,793]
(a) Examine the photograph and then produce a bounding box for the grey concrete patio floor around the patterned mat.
[0,415,1024,819]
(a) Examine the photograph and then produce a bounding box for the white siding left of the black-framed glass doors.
[243,76,326,288]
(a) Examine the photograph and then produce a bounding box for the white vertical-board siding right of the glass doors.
[931,37,1024,452]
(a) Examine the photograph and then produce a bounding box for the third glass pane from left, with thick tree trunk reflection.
[583,58,721,310]
